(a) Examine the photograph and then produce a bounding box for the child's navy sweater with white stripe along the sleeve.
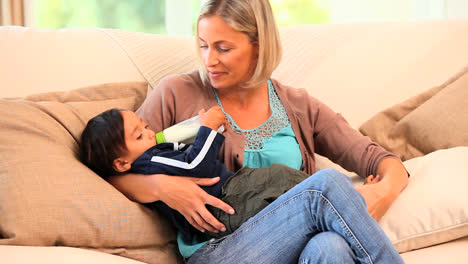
[130,126,234,243]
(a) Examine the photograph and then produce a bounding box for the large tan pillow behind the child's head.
[0,82,181,263]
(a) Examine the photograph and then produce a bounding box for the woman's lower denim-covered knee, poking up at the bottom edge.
[299,232,355,264]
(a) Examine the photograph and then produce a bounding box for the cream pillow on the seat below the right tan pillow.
[379,147,468,253]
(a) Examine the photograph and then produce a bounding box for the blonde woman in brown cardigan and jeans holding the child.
[111,0,408,263]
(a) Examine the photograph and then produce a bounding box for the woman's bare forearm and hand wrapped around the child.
[109,174,234,232]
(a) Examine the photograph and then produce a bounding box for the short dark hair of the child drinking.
[79,108,127,180]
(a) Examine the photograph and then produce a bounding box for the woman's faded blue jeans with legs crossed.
[187,169,404,264]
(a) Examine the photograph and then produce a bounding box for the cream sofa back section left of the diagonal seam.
[0,27,144,97]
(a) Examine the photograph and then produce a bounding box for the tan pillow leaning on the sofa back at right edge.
[360,67,468,160]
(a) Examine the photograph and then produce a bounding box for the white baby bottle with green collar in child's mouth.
[156,115,224,144]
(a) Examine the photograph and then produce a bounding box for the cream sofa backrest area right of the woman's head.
[274,20,468,127]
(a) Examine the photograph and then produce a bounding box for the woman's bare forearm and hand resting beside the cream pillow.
[356,158,408,221]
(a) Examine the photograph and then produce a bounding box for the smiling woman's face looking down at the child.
[198,16,258,89]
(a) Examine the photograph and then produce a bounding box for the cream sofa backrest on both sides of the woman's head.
[0,20,468,127]
